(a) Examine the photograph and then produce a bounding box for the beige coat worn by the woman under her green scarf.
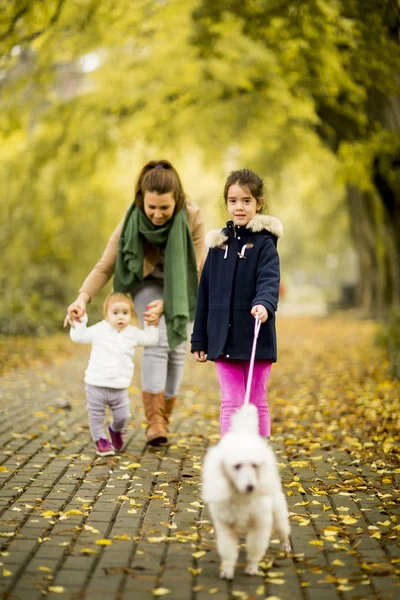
[79,200,206,302]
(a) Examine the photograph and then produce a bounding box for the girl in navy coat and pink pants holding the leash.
[191,169,282,437]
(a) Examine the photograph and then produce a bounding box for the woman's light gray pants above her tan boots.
[132,280,187,398]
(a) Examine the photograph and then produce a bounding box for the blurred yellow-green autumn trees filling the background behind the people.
[0,0,400,333]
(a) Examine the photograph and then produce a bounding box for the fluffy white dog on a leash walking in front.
[203,404,291,579]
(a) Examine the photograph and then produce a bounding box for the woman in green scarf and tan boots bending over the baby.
[64,160,205,446]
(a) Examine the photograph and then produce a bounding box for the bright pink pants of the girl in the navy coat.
[215,358,272,437]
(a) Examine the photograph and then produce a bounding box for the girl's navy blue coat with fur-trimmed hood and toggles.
[191,215,282,362]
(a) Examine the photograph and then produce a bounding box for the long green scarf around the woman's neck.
[114,204,197,350]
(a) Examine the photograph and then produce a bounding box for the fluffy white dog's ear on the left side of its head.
[202,446,231,503]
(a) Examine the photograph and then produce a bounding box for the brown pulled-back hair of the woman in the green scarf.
[134,160,186,213]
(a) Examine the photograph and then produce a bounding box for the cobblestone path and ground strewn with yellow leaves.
[0,318,400,600]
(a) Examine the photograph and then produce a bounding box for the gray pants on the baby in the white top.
[86,383,131,442]
